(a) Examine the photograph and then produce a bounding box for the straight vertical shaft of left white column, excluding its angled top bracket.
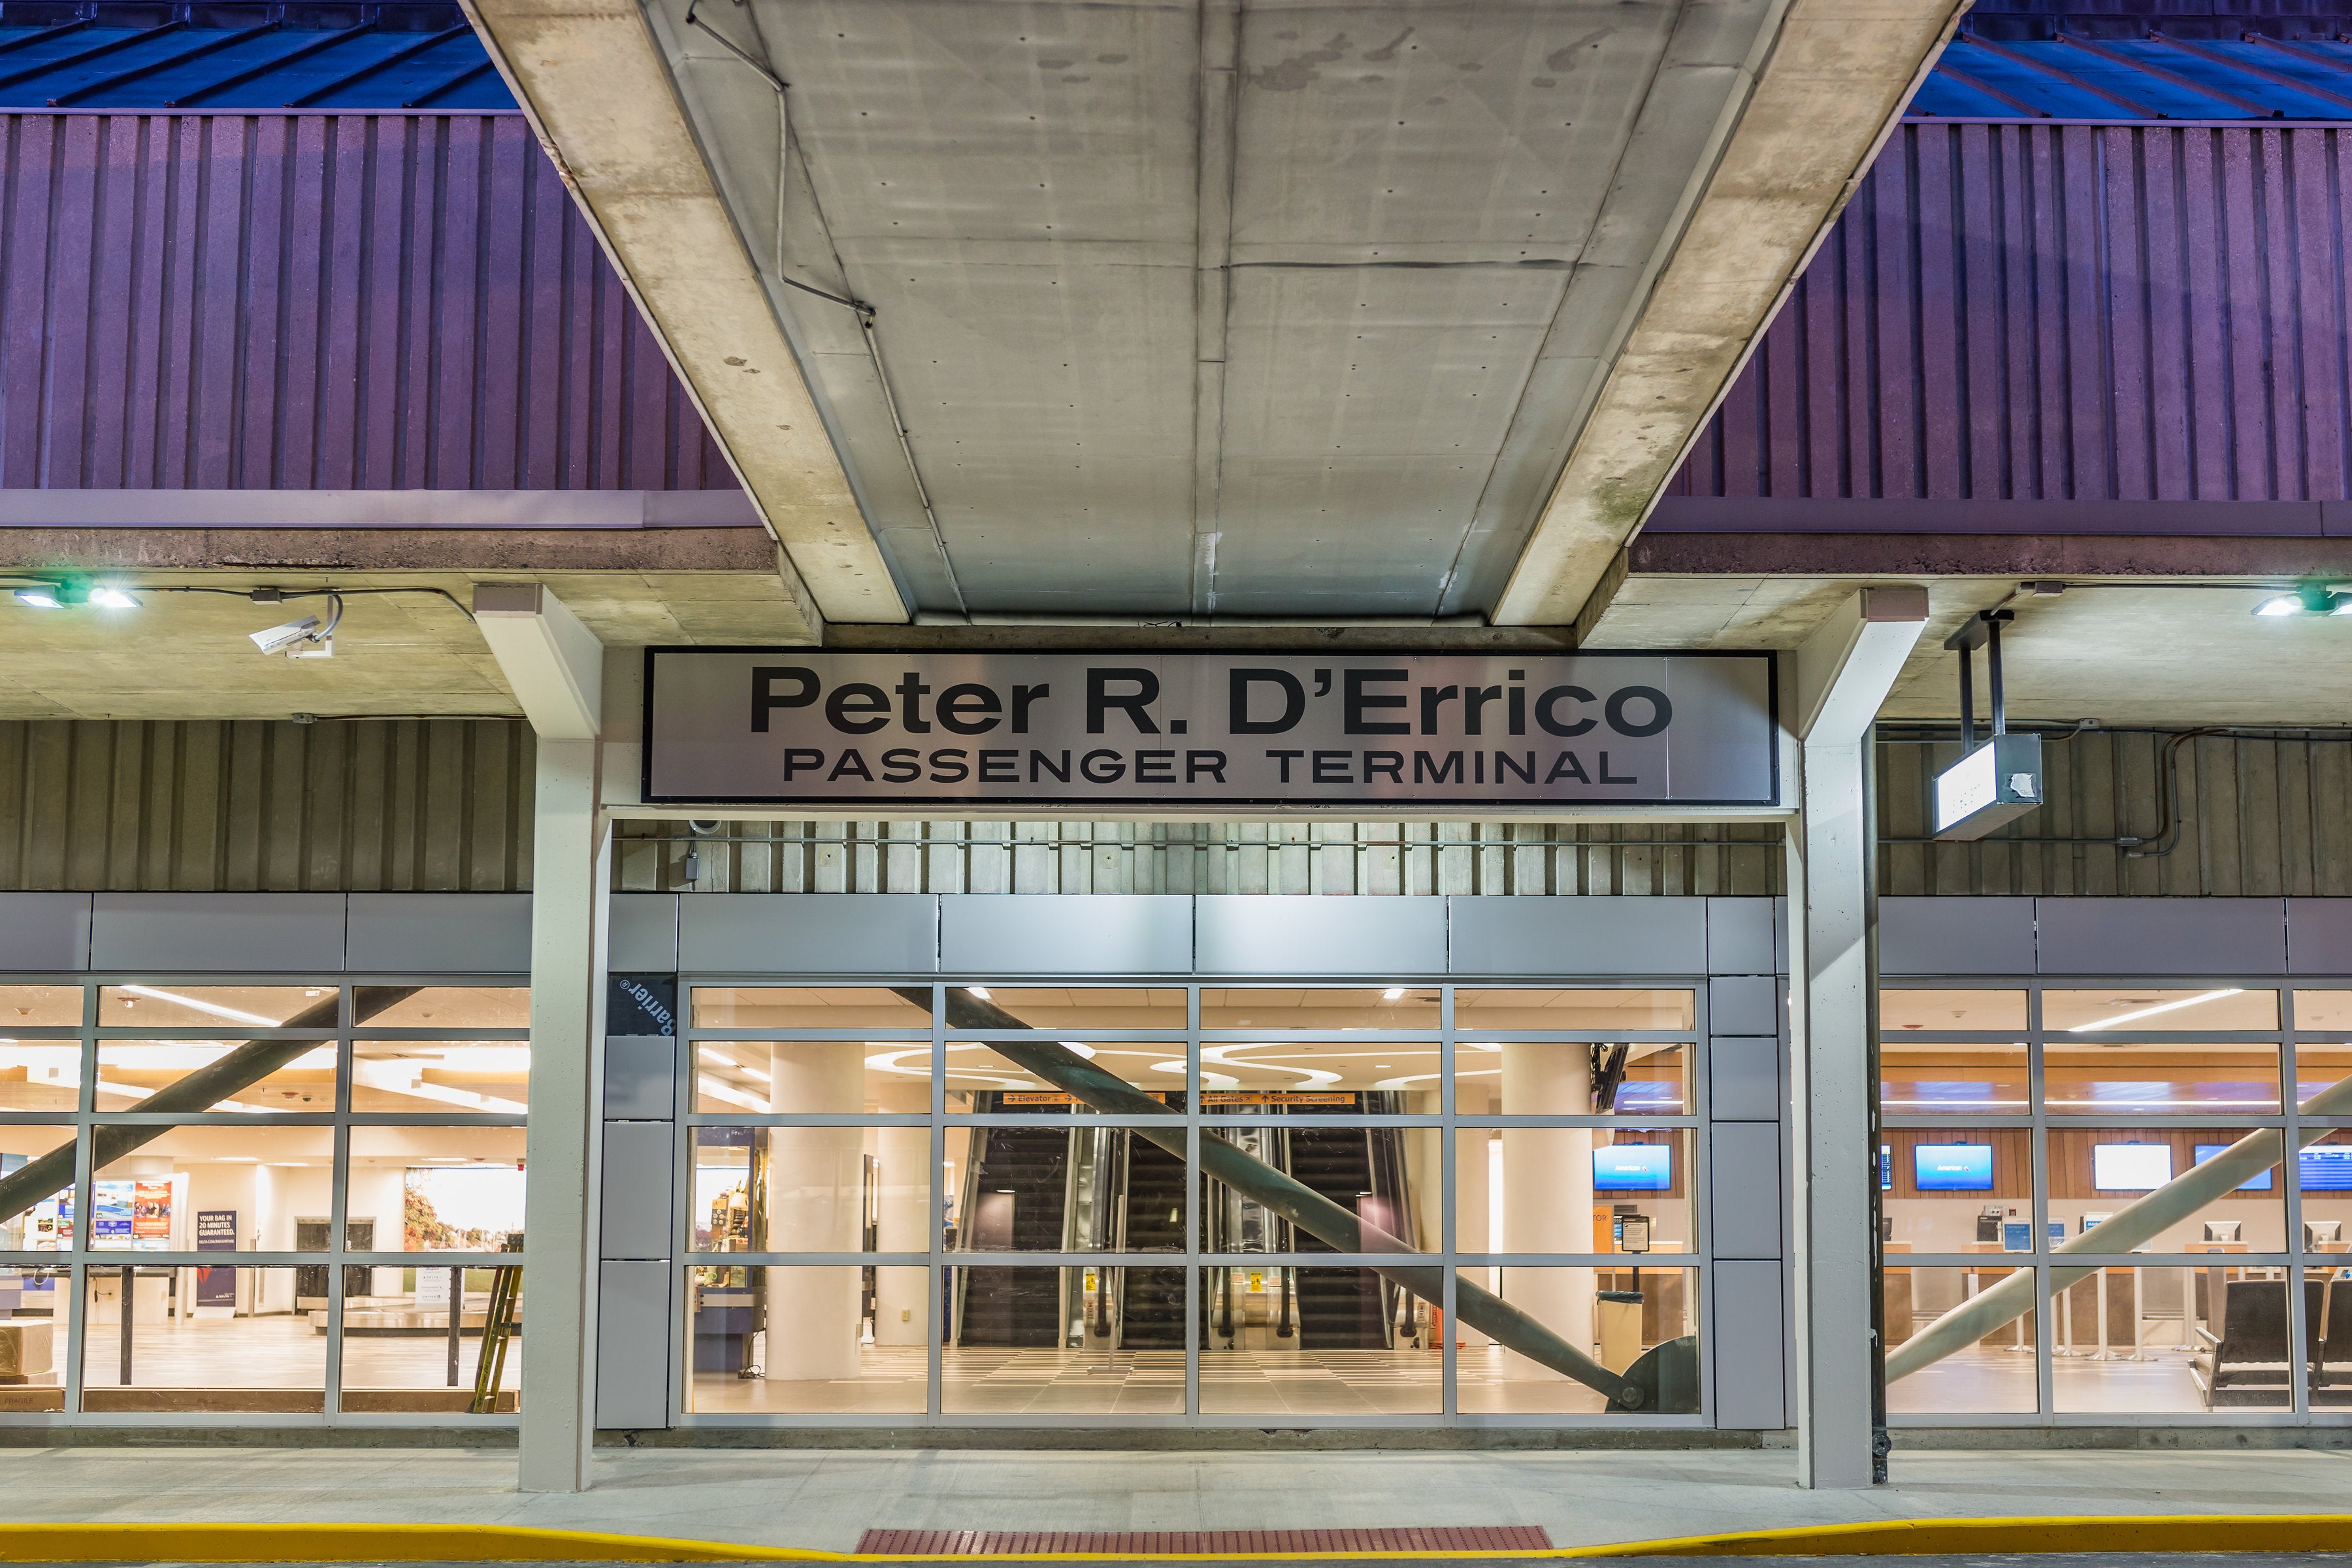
[517,738,612,1493]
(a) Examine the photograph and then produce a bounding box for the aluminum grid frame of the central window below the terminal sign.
[668,971,1717,1431]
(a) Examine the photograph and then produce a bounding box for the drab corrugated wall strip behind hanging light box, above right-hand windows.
[1879,731,2352,898]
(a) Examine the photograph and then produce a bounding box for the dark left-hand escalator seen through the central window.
[955,1105,1070,1347]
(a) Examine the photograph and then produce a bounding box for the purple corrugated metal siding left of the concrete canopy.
[0,115,734,489]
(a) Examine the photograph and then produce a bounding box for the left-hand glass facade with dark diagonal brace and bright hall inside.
[0,978,532,1425]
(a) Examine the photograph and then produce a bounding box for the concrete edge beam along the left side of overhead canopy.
[461,0,908,623]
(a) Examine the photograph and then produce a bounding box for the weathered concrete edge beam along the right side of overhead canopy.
[1494,0,1967,625]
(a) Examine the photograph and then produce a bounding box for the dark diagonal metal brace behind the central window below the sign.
[891,985,1698,1415]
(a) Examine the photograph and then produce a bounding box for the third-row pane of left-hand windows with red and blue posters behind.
[87,1124,334,1250]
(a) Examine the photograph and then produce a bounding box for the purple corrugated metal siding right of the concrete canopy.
[1670,125,2352,500]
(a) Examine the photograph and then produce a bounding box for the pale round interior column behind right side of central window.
[1505,1044,1592,1380]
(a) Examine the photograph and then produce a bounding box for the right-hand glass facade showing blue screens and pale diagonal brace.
[1879,975,2352,1425]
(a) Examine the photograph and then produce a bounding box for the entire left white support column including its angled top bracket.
[475,583,612,1493]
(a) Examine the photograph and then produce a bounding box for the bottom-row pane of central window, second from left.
[938,1265,1183,1415]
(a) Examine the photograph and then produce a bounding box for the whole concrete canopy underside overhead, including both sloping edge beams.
[468,0,1957,623]
